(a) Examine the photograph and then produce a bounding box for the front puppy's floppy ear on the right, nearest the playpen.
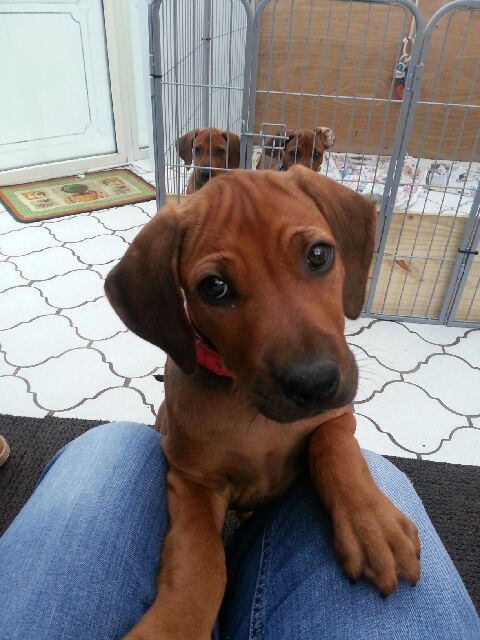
[286,165,377,319]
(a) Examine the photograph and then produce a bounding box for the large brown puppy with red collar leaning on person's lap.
[106,167,419,640]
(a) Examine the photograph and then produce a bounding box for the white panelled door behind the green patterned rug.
[0,0,127,184]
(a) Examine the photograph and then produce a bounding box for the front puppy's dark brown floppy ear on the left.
[105,207,196,373]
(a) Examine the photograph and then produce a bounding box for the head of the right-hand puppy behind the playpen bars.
[283,127,335,172]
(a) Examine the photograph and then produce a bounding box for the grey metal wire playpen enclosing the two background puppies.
[149,0,480,326]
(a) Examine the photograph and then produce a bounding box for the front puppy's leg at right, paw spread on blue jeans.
[309,413,420,595]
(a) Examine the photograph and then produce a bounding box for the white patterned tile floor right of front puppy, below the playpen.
[346,319,480,465]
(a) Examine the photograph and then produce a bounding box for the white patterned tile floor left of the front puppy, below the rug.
[0,167,165,424]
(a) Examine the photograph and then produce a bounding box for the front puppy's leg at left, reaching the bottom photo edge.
[125,470,227,640]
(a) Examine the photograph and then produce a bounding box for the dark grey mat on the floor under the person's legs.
[0,416,480,611]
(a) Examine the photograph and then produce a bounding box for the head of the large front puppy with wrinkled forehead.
[106,167,375,422]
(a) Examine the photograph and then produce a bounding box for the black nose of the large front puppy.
[275,360,340,407]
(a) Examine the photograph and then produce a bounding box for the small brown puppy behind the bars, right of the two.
[256,127,335,171]
